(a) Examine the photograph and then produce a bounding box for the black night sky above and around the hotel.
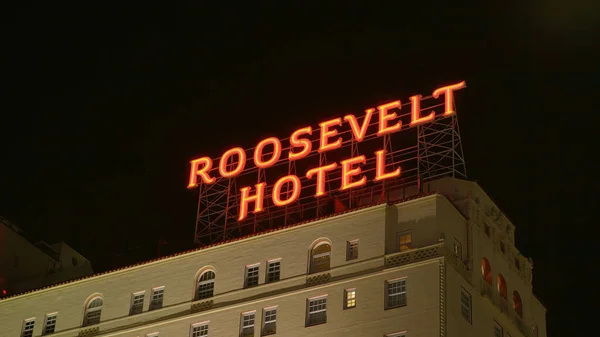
[0,1,600,336]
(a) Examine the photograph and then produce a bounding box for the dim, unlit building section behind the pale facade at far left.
[0,217,93,298]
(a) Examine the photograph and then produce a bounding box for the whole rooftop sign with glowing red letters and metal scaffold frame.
[188,82,466,244]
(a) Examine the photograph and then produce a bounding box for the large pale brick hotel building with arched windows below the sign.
[0,178,546,337]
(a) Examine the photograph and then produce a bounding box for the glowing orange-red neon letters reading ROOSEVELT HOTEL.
[188,82,466,221]
